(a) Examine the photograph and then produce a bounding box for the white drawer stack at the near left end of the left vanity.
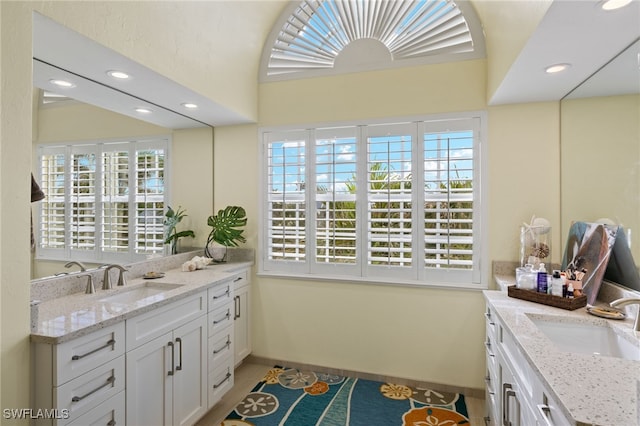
[32,323,125,425]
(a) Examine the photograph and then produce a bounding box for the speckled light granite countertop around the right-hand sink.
[483,290,640,426]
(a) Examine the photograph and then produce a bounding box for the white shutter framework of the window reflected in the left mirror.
[32,135,171,263]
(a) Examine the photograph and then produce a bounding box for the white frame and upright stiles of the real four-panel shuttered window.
[257,111,488,289]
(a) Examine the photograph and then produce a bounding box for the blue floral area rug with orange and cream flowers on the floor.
[221,367,469,426]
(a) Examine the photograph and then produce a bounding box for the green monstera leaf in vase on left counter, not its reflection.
[205,206,247,262]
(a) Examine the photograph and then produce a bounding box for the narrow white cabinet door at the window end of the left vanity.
[233,269,251,367]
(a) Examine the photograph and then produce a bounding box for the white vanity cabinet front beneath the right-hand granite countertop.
[484,304,574,426]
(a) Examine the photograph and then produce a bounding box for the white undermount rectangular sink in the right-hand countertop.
[528,315,640,361]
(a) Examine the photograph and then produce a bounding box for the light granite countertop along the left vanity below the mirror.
[31,262,253,344]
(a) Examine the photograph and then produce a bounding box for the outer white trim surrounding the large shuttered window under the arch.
[257,111,489,290]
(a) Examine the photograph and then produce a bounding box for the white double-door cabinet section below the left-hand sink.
[126,291,207,426]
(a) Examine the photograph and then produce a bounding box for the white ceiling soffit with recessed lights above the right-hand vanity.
[490,0,640,105]
